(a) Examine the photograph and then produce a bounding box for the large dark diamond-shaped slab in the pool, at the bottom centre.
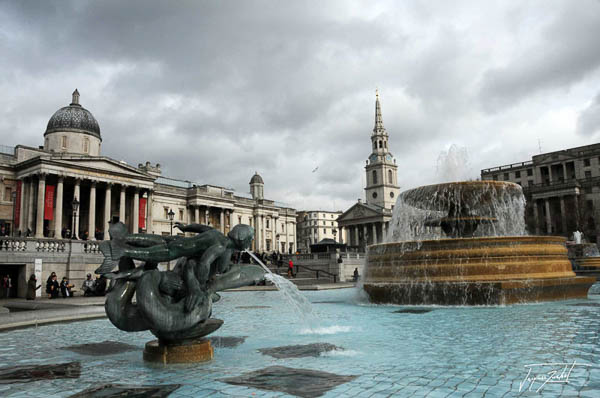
[219,366,358,398]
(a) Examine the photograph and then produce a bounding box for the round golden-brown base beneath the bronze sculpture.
[144,339,214,364]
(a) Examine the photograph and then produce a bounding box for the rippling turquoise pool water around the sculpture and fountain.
[0,289,600,397]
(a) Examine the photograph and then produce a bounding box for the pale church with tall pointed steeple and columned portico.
[338,93,400,250]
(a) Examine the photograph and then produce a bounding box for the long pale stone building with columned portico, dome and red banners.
[0,90,296,253]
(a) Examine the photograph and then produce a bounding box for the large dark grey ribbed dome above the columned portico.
[44,89,102,140]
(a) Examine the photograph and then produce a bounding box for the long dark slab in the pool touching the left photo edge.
[0,362,81,384]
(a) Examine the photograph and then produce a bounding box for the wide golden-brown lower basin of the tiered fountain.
[364,236,595,305]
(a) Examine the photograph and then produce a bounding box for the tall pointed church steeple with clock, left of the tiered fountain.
[365,91,400,209]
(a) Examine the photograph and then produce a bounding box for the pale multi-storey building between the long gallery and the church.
[296,210,346,253]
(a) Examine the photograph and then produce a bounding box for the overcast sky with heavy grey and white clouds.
[0,0,600,210]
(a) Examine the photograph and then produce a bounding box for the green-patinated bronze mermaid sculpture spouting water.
[96,222,265,344]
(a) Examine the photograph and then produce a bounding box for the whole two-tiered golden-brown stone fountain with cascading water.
[364,176,595,305]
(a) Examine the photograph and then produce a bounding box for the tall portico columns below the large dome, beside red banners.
[18,174,152,239]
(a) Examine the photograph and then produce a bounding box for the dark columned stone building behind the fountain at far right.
[481,144,600,243]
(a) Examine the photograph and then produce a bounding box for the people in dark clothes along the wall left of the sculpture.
[26,272,107,300]
